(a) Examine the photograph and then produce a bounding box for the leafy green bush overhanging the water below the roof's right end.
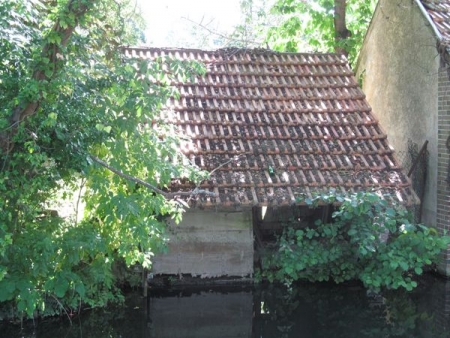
[261,192,450,290]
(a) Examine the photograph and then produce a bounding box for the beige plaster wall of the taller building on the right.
[356,0,439,225]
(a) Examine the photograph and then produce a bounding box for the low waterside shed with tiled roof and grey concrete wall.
[125,48,416,277]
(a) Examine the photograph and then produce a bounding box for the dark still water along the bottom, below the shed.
[0,276,450,338]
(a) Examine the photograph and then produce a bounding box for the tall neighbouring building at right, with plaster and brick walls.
[357,0,450,275]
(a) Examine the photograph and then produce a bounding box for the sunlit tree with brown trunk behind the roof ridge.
[237,0,376,62]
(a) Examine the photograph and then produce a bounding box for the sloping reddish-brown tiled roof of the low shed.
[125,48,415,207]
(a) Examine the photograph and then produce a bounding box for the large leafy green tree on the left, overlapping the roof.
[0,0,204,316]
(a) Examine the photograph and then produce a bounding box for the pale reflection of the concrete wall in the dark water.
[149,288,253,338]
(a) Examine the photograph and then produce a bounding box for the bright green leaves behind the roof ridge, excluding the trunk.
[235,0,376,64]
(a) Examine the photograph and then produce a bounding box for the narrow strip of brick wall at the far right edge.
[436,68,450,276]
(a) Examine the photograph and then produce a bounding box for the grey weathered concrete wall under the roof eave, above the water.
[151,209,253,278]
